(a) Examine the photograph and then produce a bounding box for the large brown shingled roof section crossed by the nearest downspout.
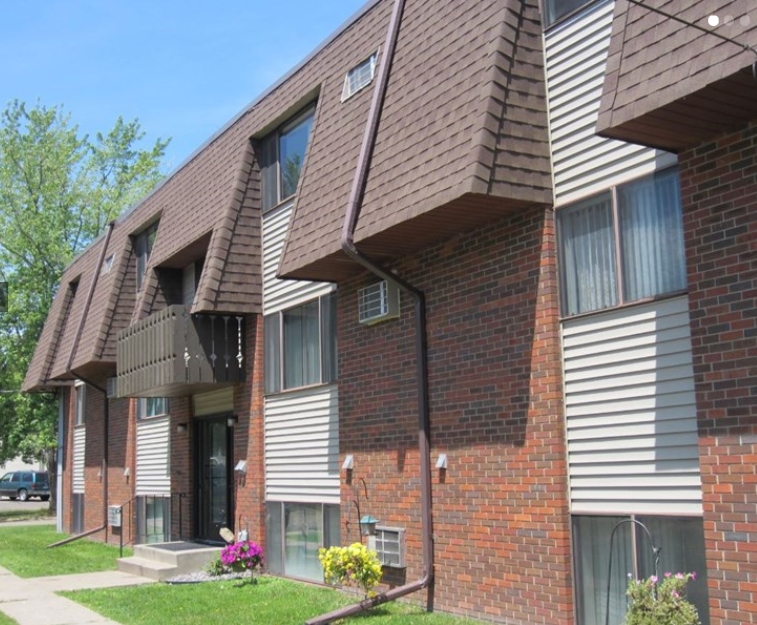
[279,0,551,280]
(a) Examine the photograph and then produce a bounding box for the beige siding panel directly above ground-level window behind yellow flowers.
[265,386,339,504]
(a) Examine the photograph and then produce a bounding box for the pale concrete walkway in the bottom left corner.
[0,567,155,625]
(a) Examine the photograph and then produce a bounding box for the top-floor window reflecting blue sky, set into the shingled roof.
[258,107,315,210]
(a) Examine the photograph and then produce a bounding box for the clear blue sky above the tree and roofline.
[0,0,366,171]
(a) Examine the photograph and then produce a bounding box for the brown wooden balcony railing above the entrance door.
[117,306,244,397]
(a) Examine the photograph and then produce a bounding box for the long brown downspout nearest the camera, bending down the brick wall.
[306,0,434,625]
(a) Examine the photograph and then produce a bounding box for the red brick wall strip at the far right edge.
[680,124,757,625]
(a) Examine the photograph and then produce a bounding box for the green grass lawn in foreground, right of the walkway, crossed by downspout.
[68,576,488,625]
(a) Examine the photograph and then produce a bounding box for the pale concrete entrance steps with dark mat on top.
[118,542,221,581]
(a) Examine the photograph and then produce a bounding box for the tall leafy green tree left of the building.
[0,101,168,505]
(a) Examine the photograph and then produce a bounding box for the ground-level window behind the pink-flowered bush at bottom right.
[573,516,709,625]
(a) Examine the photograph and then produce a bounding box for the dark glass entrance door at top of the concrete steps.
[195,416,234,542]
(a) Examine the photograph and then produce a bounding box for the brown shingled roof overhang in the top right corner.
[597,0,757,151]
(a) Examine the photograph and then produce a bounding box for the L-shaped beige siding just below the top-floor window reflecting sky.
[263,202,334,315]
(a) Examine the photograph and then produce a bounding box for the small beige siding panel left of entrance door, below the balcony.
[136,416,171,495]
